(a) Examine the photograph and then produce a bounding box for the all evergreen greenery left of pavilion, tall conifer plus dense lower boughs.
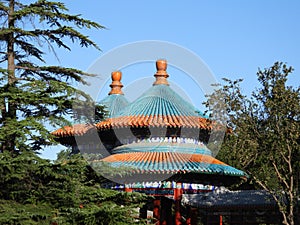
[0,0,150,225]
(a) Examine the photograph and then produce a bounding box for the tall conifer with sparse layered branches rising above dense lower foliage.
[0,0,103,152]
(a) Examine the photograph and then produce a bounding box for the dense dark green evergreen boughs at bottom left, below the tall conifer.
[0,152,147,225]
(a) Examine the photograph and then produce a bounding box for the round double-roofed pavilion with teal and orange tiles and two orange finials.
[53,60,280,225]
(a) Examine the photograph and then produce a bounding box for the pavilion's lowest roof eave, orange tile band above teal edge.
[97,152,247,177]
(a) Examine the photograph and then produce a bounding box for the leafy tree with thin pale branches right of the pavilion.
[206,62,300,225]
